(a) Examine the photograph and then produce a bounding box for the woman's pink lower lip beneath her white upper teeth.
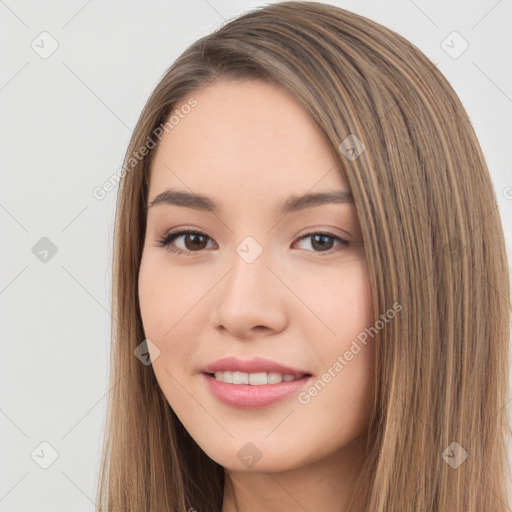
[202,373,311,409]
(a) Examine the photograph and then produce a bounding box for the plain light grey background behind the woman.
[0,0,512,512]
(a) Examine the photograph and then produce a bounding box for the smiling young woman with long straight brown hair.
[98,2,510,512]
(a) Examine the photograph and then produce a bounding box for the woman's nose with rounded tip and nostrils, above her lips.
[210,249,289,339]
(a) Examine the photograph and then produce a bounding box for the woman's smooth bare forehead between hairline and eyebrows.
[150,80,346,201]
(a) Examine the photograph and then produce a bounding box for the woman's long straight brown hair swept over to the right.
[97,1,510,512]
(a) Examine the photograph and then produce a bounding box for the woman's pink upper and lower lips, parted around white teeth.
[202,357,312,409]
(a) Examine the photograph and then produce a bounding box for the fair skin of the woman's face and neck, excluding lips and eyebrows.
[139,80,374,512]
